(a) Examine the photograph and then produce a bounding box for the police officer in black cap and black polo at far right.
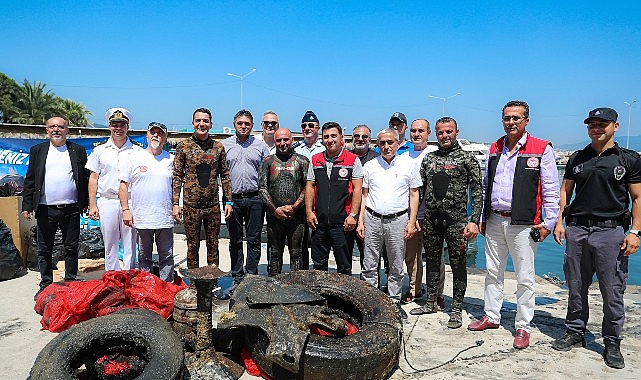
[552,108,641,369]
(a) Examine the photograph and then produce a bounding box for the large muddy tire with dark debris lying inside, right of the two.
[246,270,402,379]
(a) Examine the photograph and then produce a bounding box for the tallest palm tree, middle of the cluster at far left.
[12,79,56,124]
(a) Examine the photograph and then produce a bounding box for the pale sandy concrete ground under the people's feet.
[0,234,641,379]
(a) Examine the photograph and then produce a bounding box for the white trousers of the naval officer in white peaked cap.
[96,197,136,270]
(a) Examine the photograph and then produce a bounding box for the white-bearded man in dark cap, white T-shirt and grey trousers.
[118,122,174,282]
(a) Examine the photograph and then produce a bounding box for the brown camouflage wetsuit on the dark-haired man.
[172,135,231,268]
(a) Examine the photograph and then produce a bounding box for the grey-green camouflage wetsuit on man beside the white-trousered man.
[420,142,482,312]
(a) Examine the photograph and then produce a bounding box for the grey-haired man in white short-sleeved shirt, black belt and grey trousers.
[357,128,422,319]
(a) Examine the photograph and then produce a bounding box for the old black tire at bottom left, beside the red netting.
[29,309,184,380]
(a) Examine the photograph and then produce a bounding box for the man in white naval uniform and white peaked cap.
[85,108,142,271]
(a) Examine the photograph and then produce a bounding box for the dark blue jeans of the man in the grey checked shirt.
[227,196,265,283]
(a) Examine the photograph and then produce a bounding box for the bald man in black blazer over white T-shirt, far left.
[22,117,89,300]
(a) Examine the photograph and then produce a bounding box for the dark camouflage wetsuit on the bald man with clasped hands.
[258,152,309,276]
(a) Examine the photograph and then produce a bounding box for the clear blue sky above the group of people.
[0,0,641,145]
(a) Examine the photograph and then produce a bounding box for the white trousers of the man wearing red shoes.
[485,213,538,332]
